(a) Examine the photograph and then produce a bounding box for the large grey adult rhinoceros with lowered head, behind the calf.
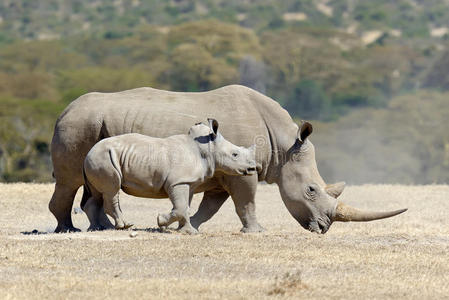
[49,85,405,233]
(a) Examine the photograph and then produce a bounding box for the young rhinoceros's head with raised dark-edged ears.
[189,119,256,175]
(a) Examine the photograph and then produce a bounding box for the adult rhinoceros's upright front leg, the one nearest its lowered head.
[224,175,265,233]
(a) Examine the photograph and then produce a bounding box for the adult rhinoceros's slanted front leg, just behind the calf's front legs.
[190,189,229,230]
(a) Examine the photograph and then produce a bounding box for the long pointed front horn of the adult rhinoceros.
[333,202,407,222]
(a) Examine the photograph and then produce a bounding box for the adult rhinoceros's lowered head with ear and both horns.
[278,122,406,234]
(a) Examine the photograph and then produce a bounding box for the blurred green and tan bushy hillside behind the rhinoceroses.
[0,0,449,184]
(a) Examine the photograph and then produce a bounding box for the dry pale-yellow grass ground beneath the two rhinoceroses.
[0,184,449,299]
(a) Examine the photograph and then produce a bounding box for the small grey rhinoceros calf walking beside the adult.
[81,119,256,234]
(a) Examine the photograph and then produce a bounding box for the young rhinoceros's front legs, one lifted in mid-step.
[157,184,198,234]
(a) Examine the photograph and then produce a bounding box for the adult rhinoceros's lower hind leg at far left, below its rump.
[48,183,81,233]
